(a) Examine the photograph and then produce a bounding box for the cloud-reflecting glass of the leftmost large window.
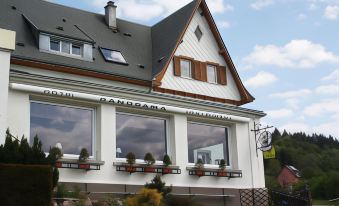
[30,102,94,155]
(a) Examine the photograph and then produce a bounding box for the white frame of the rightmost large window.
[187,121,233,169]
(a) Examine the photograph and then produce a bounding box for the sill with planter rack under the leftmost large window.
[55,159,105,170]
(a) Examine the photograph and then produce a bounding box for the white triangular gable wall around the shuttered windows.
[161,12,241,100]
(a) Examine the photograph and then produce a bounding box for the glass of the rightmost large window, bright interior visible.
[187,123,229,165]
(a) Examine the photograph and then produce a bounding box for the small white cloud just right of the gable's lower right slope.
[244,71,278,88]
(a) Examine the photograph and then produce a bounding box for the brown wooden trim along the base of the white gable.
[153,87,244,106]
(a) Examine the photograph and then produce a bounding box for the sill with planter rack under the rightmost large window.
[186,166,242,179]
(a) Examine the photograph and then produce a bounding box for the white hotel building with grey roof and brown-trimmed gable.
[0,0,265,205]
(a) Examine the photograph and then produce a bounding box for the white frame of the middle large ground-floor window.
[115,112,171,164]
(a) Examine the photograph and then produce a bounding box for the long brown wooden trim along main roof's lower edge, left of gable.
[11,59,152,87]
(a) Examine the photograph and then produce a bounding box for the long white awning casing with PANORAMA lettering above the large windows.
[10,83,250,122]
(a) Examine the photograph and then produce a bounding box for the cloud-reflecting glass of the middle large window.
[116,114,166,160]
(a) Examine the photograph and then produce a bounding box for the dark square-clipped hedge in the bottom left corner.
[0,164,53,206]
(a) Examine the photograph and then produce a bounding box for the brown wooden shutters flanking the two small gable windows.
[173,56,227,85]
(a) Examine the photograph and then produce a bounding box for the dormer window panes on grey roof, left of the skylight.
[50,38,82,56]
